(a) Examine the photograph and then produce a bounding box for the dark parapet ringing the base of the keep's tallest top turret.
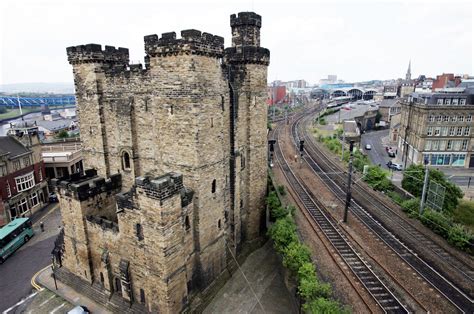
[224,46,270,66]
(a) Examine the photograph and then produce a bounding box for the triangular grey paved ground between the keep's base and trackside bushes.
[203,241,298,314]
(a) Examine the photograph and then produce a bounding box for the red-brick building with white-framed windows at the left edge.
[0,127,48,227]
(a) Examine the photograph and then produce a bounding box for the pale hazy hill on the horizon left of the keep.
[0,83,74,94]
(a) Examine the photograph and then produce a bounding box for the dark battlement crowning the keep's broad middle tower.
[144,29,224,58]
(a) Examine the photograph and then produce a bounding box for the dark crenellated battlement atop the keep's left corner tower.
[66,44,129,65]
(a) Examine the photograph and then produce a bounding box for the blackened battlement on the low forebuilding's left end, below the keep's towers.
[51,169,122,201]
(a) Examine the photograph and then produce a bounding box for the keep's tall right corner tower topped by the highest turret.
[225,12,270,242]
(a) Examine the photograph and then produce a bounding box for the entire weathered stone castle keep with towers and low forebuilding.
[55,12,270,313]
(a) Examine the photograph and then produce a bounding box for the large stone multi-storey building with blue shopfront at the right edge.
[398,89,474,168]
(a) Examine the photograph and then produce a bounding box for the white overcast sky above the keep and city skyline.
[0,0,474,84]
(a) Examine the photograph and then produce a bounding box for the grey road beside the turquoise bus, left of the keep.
[0,206,61,313]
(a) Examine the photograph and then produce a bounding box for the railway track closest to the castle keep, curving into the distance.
[275,121,409,313]
